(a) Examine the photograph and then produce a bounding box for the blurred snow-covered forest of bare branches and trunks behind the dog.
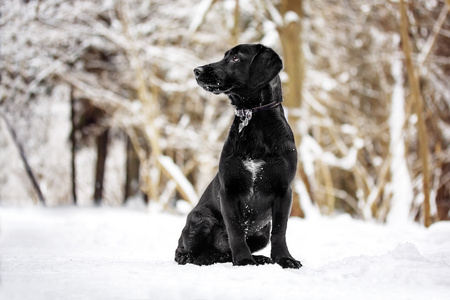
[0,0,450,226]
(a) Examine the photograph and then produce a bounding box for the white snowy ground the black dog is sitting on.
[0,207,450,300]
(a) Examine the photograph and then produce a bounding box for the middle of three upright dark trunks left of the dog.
[94,129,109,205]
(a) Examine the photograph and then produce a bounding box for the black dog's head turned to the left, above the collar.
[194,44,283,101]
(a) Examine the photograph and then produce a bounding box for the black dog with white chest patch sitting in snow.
[175,44,301,268]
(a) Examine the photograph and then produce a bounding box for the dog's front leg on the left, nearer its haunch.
[220,189,256,266]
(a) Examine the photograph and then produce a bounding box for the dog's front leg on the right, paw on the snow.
[270,188,302,269]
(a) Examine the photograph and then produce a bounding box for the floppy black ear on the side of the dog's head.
[249,45,283,89]
